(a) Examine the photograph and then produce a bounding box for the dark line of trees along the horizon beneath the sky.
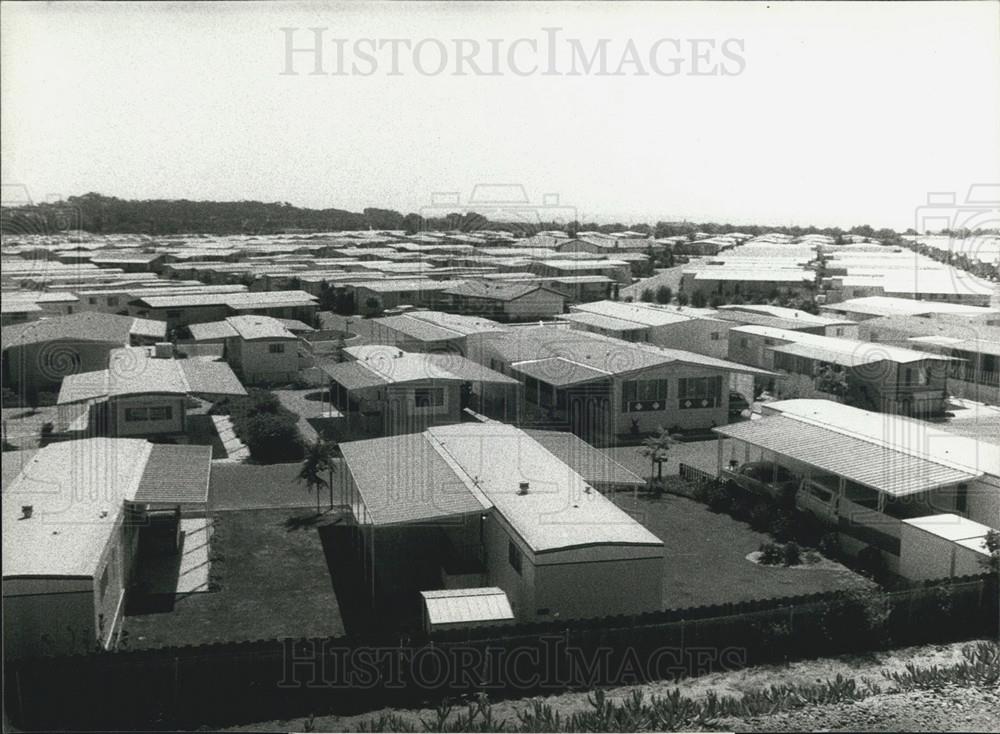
[0,193,915,241]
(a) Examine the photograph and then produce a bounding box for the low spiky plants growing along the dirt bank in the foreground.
[346,642,1000,732]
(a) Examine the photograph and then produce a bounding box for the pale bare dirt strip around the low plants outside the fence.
[223,642,1000,731]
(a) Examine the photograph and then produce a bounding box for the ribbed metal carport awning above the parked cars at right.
[714,415,978,497]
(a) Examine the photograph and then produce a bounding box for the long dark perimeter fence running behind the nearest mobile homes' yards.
[4,574,1000,730]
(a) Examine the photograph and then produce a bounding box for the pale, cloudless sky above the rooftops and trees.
[0,2,1000,229]
